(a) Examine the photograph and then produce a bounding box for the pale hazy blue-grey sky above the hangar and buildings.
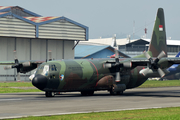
[0,0,180,40]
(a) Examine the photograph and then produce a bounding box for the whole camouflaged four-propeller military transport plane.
[0,8,180,97]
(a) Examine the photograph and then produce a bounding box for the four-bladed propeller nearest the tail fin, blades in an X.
[140,51,166,77]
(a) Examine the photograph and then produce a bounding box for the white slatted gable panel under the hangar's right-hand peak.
[39,20,86,40]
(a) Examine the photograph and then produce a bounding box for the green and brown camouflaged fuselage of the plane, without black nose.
[36,59,147,92]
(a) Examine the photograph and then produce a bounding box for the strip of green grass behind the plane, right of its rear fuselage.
[139,80,180,88]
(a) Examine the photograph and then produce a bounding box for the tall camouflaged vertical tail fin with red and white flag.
[148,8,167,57]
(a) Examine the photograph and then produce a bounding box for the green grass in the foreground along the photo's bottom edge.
[10,107,180,120]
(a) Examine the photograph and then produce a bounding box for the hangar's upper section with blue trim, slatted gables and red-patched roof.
[0,6,88,41]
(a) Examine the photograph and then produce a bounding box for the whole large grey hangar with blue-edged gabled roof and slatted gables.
[0,6,88,81]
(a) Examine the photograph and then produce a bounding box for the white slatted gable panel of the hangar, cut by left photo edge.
[0,16,35,38]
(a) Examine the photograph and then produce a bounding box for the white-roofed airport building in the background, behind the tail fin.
[79,37,180,57]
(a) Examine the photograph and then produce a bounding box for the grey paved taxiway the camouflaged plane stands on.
[0,87,180,119]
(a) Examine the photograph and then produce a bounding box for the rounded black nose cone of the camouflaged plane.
[32,75,48,90]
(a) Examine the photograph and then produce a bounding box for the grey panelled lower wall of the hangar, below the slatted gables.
[0,37,74,81]
